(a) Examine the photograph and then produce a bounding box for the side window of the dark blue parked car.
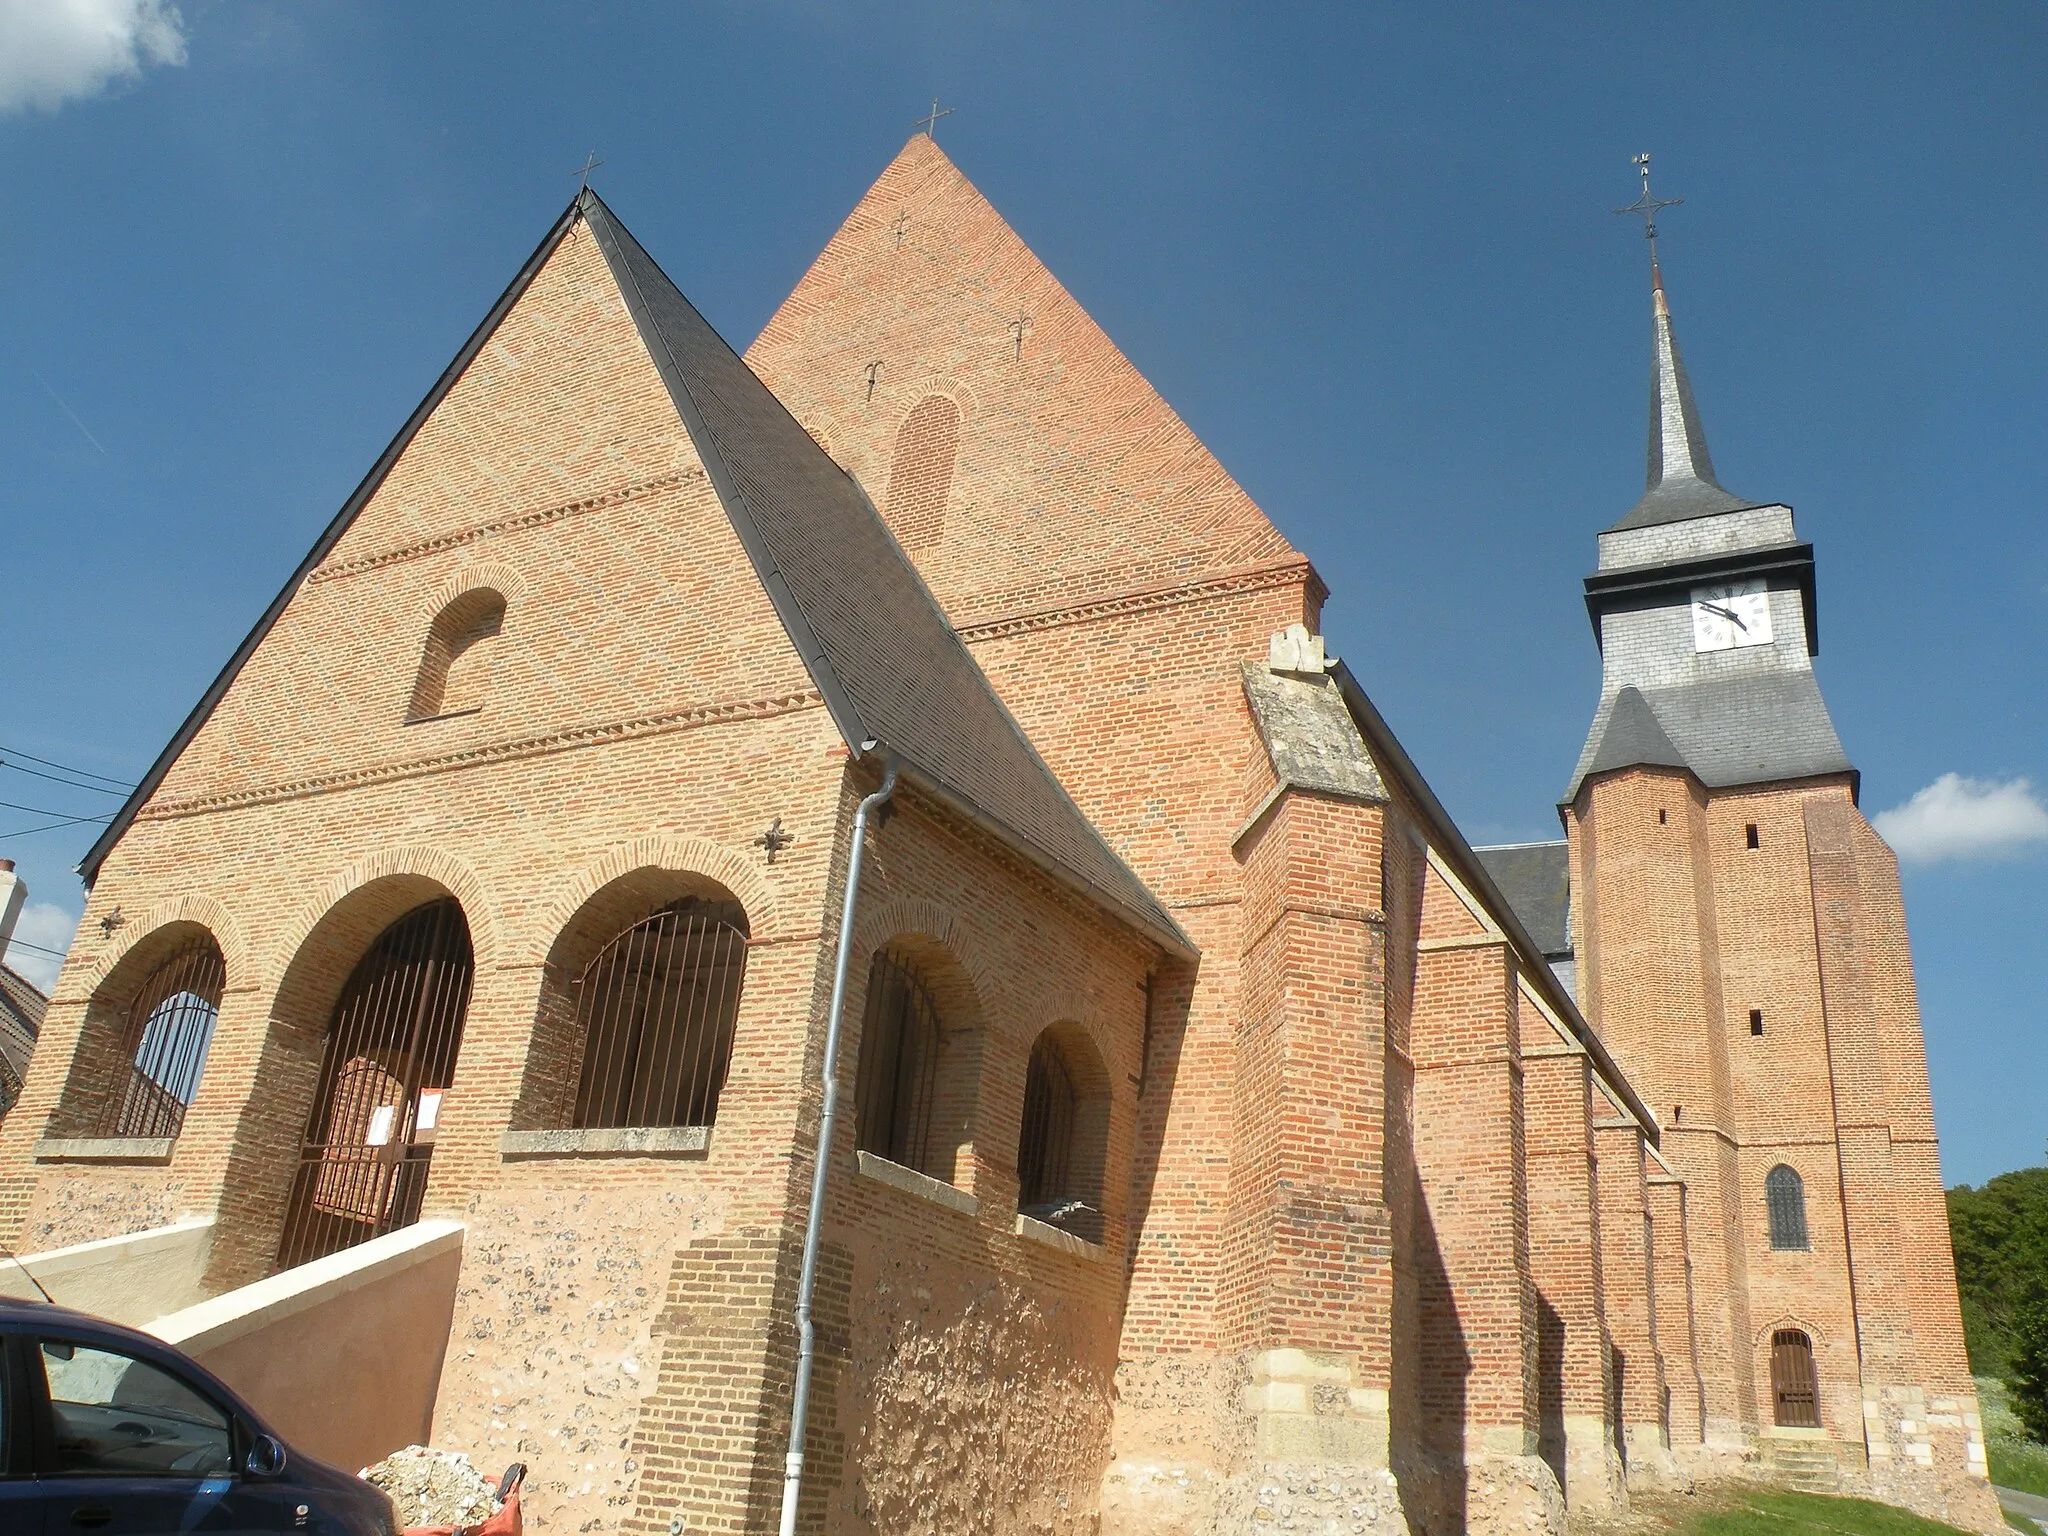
[37,1339,236,1477]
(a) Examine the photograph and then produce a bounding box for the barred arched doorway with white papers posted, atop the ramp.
[276,897,475,1270]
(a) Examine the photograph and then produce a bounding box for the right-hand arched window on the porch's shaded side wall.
[1018,1024,1110,1243]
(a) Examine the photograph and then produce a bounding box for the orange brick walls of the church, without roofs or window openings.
[0,137,1982,1536]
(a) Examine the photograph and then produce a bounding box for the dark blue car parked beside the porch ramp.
[0,1298,397,1536]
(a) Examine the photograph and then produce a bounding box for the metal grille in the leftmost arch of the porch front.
[92,938,227,1137]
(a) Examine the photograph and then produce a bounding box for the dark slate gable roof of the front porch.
[80,190,1194,954]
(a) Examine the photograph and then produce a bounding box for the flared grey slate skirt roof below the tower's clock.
[1565,668,1855,805]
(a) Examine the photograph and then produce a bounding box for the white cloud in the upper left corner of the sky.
[0,0,184,113]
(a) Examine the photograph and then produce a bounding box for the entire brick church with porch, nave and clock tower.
[0,133,2001,1536]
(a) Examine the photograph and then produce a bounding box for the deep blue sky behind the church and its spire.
[0,0,2048,1182]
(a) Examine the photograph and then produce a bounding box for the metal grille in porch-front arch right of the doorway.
[575,897,748,1130]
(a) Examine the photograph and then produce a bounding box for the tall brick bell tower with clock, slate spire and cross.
[1559,160,1989,1524]
